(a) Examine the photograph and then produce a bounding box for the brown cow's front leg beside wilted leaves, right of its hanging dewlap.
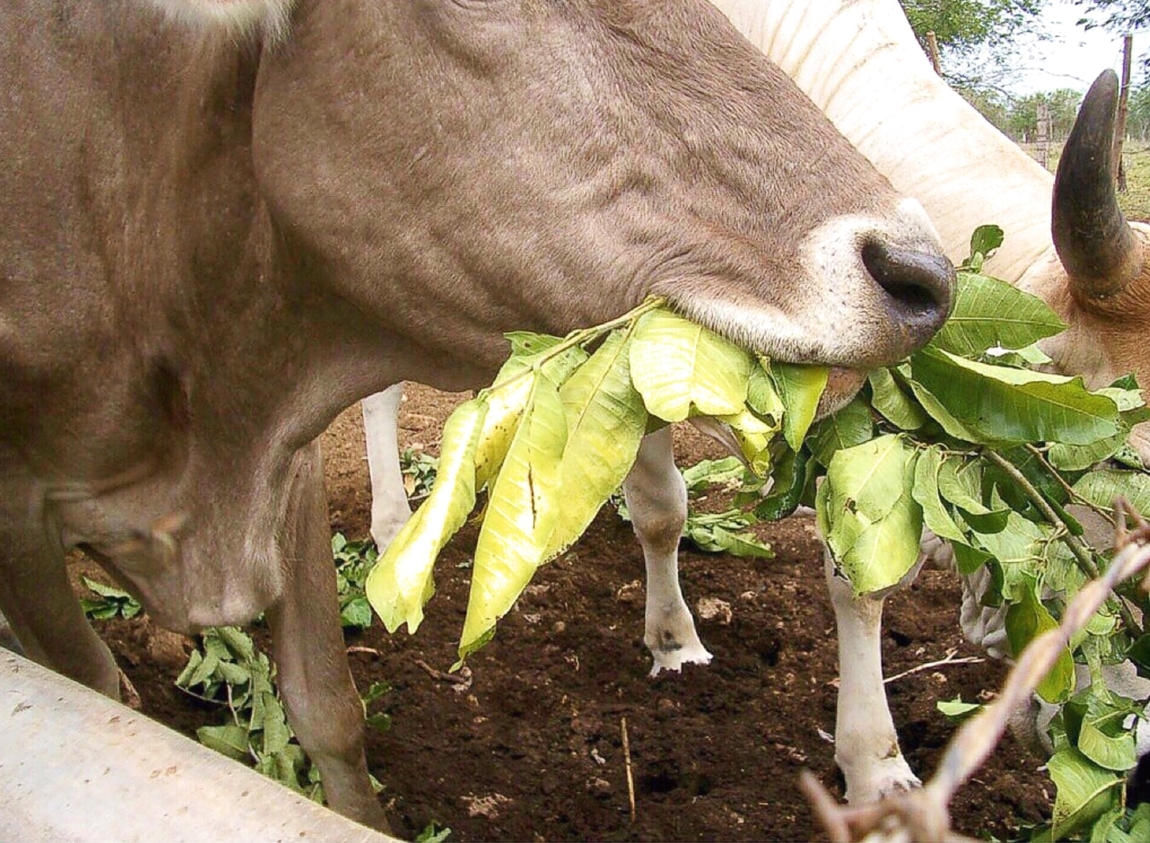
[267,443,388,830]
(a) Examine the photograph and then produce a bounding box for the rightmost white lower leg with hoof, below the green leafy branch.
[825,552,921,804]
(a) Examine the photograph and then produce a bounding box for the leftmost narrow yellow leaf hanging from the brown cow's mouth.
[366,398,488,633]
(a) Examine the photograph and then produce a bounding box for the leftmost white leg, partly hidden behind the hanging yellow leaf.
[360,383,412,552]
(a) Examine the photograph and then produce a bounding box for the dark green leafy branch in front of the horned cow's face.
[805,226,1150,841]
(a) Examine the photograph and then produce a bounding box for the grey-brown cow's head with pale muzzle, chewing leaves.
[253,0,953,411]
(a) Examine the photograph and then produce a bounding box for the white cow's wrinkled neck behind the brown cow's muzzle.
[712,0,1053,281]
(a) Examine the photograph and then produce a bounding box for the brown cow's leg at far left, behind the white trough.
[0,521,120,700]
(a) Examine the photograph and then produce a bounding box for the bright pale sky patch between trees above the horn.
[1005,0,1150,94]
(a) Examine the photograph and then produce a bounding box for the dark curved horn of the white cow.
[1051,70,1142,298]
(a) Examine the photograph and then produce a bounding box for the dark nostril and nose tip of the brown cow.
[863,240,955,334]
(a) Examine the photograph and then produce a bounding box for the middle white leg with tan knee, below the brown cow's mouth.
[623,428,711,676]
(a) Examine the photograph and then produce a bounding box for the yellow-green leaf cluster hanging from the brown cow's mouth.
[367,299,809,659]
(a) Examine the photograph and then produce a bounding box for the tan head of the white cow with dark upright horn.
[1020,70,1150,460]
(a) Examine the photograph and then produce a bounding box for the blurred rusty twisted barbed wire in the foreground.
[800,499,1150,843]
